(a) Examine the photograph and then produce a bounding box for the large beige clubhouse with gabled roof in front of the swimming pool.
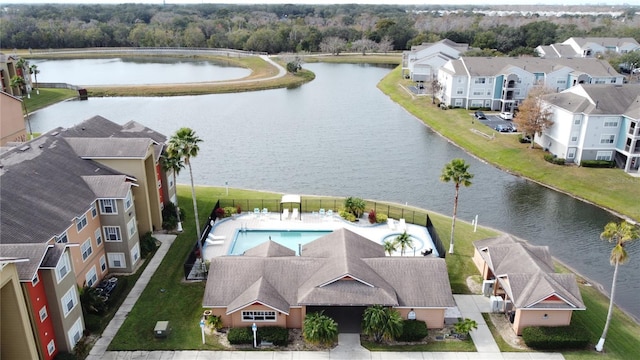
[203,228,455,332]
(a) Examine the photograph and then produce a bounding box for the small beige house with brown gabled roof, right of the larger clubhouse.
[473,235,586,335]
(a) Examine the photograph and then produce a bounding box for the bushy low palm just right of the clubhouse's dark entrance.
[362,305,403,343]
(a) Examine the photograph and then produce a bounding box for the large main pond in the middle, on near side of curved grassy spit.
[31,59,640,317]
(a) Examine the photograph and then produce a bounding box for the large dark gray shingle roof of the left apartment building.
[0,129,120,244]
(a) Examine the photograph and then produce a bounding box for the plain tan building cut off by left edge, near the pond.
[0,91,27,146]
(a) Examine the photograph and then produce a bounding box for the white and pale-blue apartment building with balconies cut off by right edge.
[535,84,640,174]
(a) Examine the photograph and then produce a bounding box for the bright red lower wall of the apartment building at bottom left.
[24,271,58,360]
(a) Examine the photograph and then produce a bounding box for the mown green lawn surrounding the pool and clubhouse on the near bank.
[109,186,640,359]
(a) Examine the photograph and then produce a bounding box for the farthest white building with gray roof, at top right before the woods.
[536,37,640,59]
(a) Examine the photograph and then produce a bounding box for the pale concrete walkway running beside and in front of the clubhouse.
[87,234,564,360]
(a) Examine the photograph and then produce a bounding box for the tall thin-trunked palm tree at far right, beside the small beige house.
[596,221,640,351]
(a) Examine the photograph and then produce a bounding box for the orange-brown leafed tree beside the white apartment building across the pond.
[513,85,553,149]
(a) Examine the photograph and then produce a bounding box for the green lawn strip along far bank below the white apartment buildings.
[378,67,640,221]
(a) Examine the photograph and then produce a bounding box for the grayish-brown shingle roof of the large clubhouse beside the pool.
[203,229,455,312]
